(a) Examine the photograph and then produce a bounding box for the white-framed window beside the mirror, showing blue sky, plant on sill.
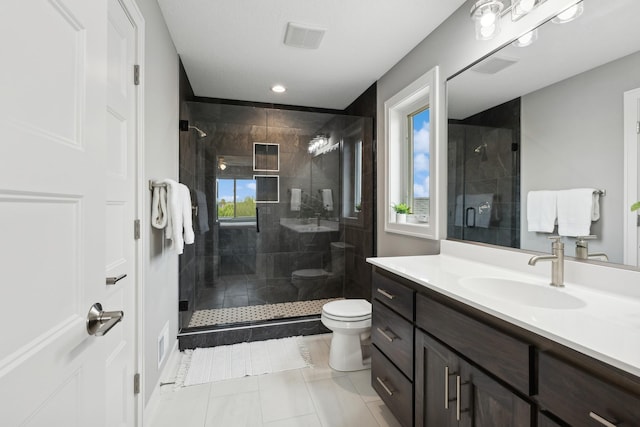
[383,67,447,239]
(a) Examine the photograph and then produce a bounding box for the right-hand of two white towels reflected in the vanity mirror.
[558,188,600,237]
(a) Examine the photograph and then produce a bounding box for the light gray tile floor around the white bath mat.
[148,334,399,427]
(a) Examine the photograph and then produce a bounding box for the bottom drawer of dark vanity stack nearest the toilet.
[371,347,413,426]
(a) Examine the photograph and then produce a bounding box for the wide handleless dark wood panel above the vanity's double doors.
[416,295,532,394]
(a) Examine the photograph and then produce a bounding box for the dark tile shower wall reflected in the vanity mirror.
[447,98,520,248]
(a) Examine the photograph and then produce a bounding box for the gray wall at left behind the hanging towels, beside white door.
[136,0,178,405]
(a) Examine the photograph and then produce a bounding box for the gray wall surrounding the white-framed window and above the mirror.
[376,0,571,256]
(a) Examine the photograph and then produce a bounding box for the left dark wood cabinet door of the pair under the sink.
[415,330,460,427]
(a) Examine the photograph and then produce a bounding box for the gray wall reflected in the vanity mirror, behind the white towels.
[521,53,640,263]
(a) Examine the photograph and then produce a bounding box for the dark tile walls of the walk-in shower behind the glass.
[181,102,374,325]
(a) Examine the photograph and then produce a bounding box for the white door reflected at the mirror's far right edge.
[623,88,640,267]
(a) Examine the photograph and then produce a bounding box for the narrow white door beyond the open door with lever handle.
[103,0,137,427]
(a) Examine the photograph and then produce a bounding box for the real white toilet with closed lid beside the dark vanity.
[320,299,371,371]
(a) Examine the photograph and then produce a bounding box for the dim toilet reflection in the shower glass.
[291,242,353,301]
